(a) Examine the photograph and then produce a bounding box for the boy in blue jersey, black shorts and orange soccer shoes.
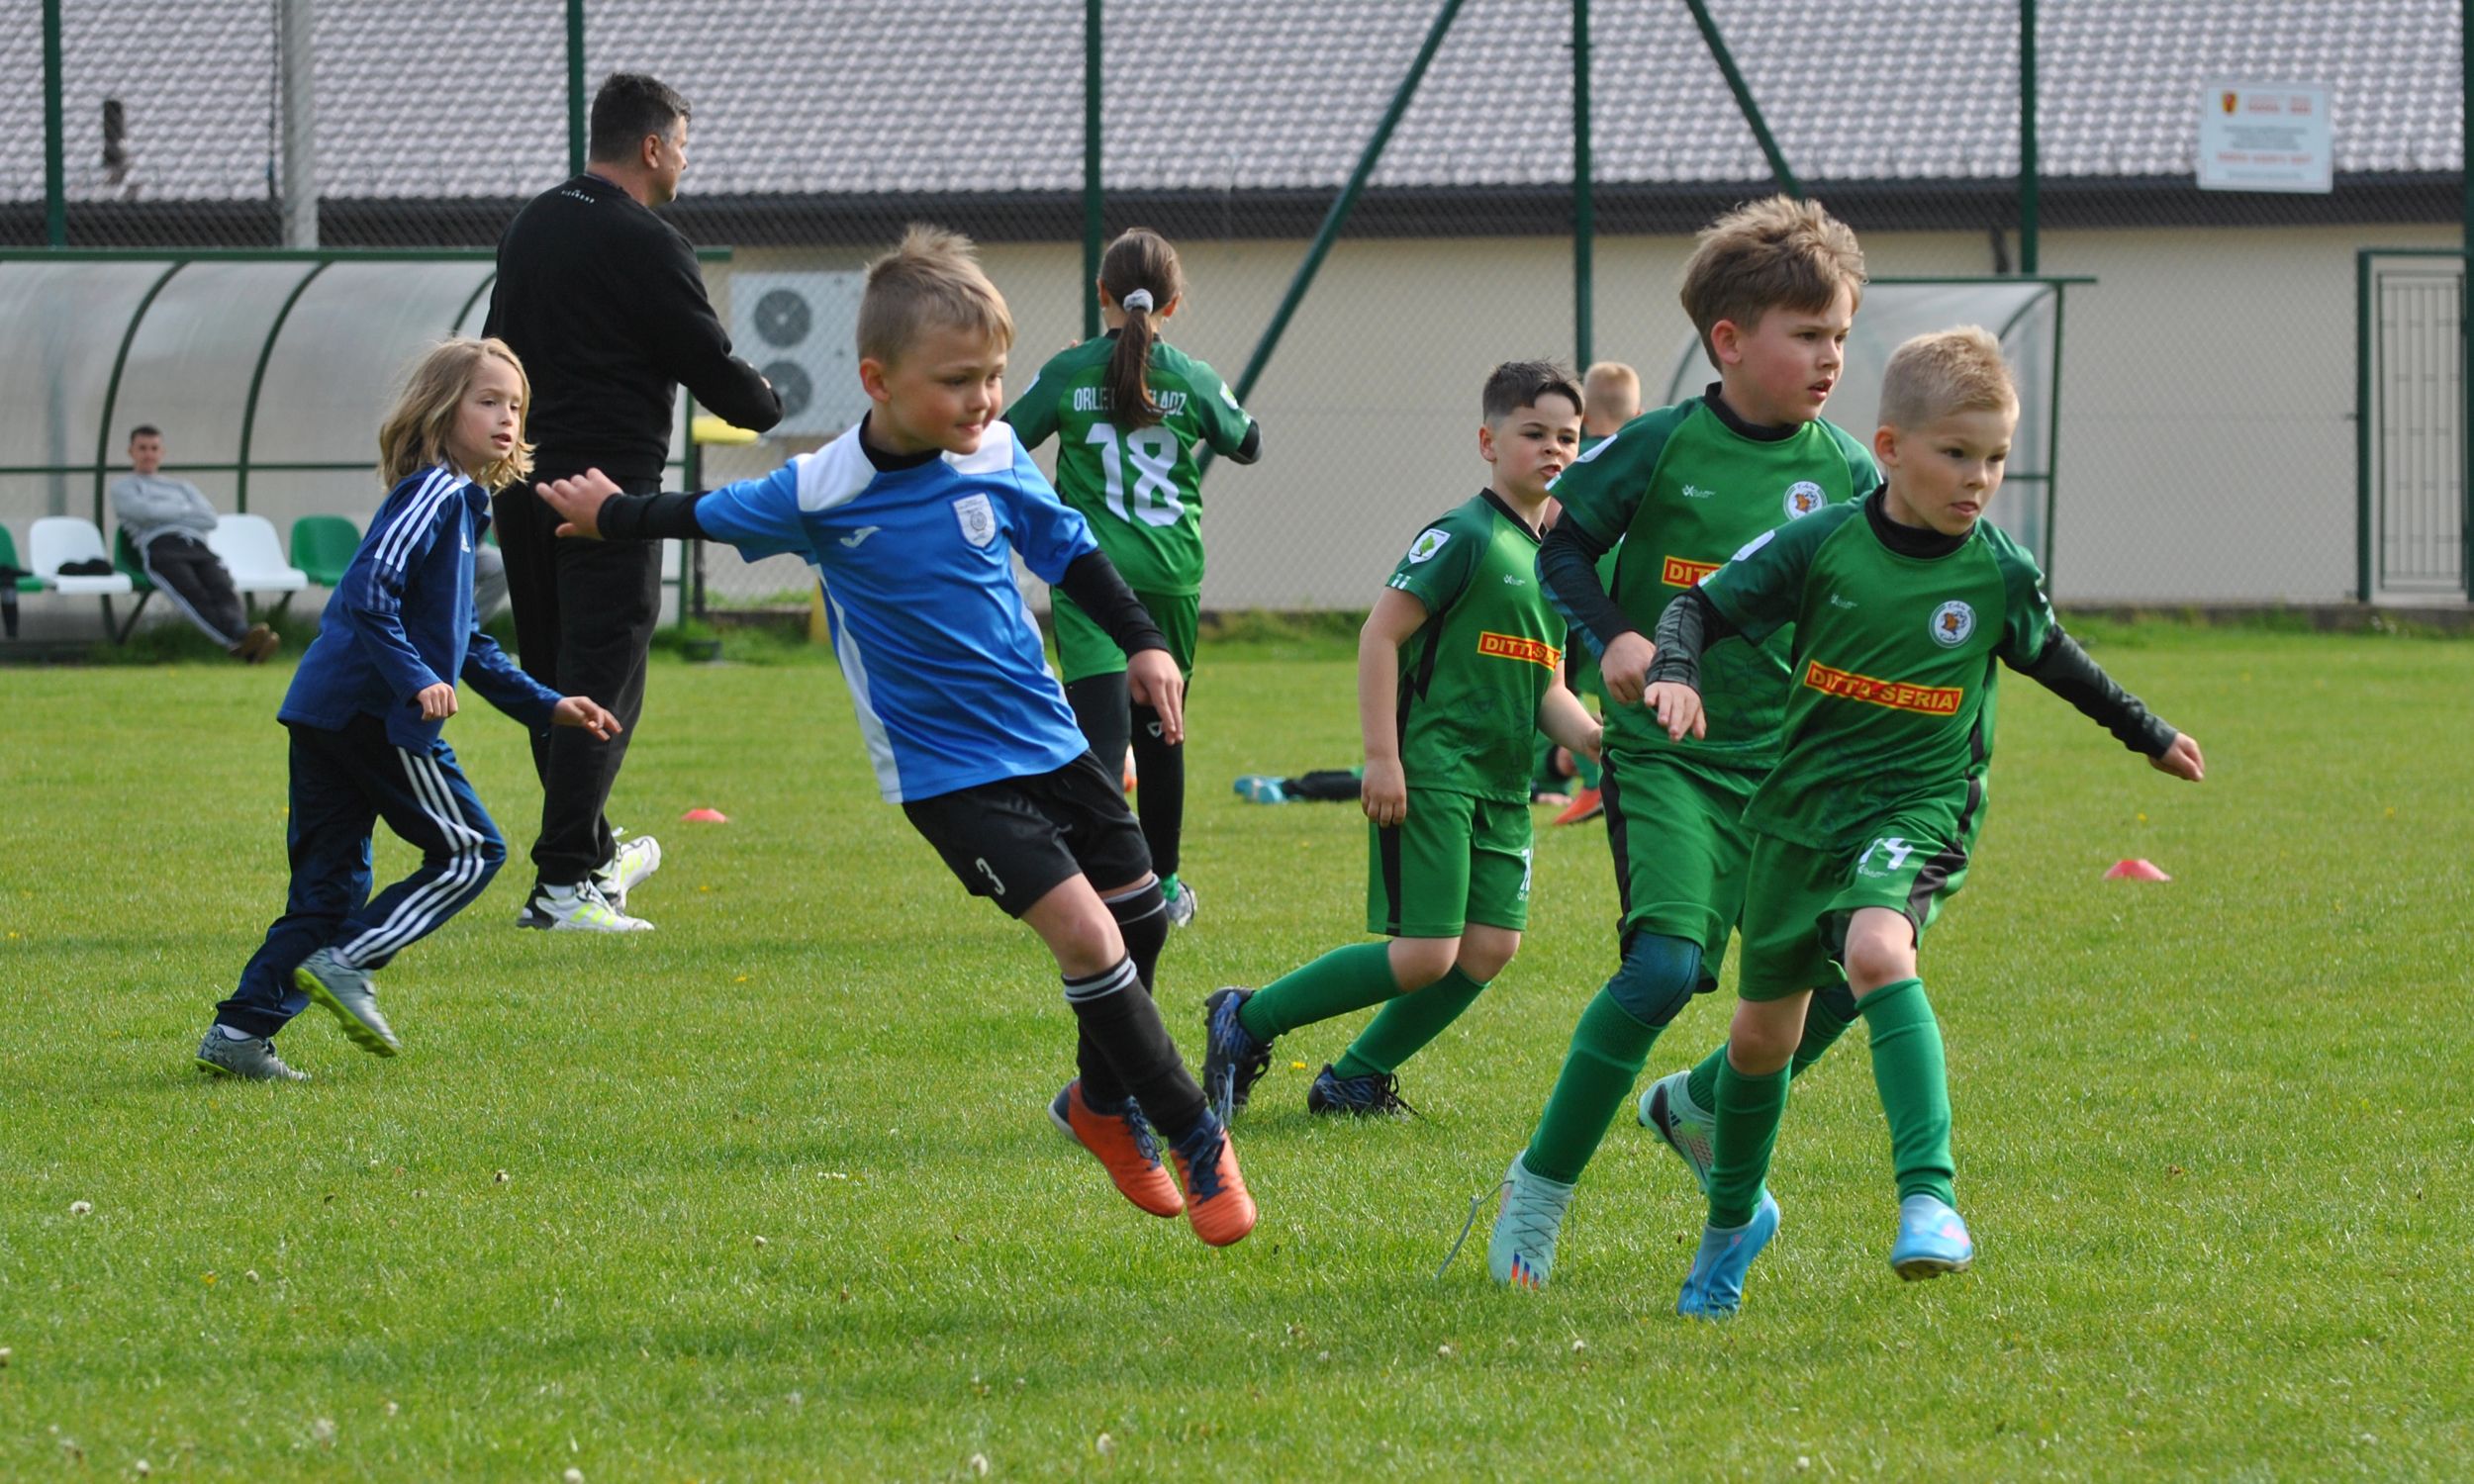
[537,228,1255,1247]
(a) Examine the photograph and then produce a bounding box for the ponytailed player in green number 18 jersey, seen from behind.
[1004,228,1262,928]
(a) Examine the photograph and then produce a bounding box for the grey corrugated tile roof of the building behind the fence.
[0,0,2464,201]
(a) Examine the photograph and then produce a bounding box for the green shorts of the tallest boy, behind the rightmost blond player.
[1598,750,1761,994]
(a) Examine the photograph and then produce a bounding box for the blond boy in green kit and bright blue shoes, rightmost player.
[1646,326,2205,1319]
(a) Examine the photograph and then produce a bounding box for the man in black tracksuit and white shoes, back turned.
[485,72,782,933]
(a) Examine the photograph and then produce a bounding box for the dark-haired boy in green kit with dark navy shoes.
[1202,361,1598,1113]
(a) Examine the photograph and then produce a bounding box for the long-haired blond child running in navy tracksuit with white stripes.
[198,339,618,1081]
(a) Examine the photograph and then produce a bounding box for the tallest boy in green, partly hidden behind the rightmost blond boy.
[1487,196,1880,1289]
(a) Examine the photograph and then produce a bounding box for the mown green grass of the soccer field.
[0,628,2474,1484]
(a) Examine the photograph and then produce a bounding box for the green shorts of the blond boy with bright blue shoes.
[1737,819,1967,999]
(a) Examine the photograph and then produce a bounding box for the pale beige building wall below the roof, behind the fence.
[713,228,2457,608]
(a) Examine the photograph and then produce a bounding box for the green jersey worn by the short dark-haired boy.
[1385,490,1564,804]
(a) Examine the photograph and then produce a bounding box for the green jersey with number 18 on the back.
[1004,331,1255,599]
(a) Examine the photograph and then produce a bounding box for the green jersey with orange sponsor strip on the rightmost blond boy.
[1702,503,2053,849]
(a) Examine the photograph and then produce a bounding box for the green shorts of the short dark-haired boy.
[1366,789,1529,938]
